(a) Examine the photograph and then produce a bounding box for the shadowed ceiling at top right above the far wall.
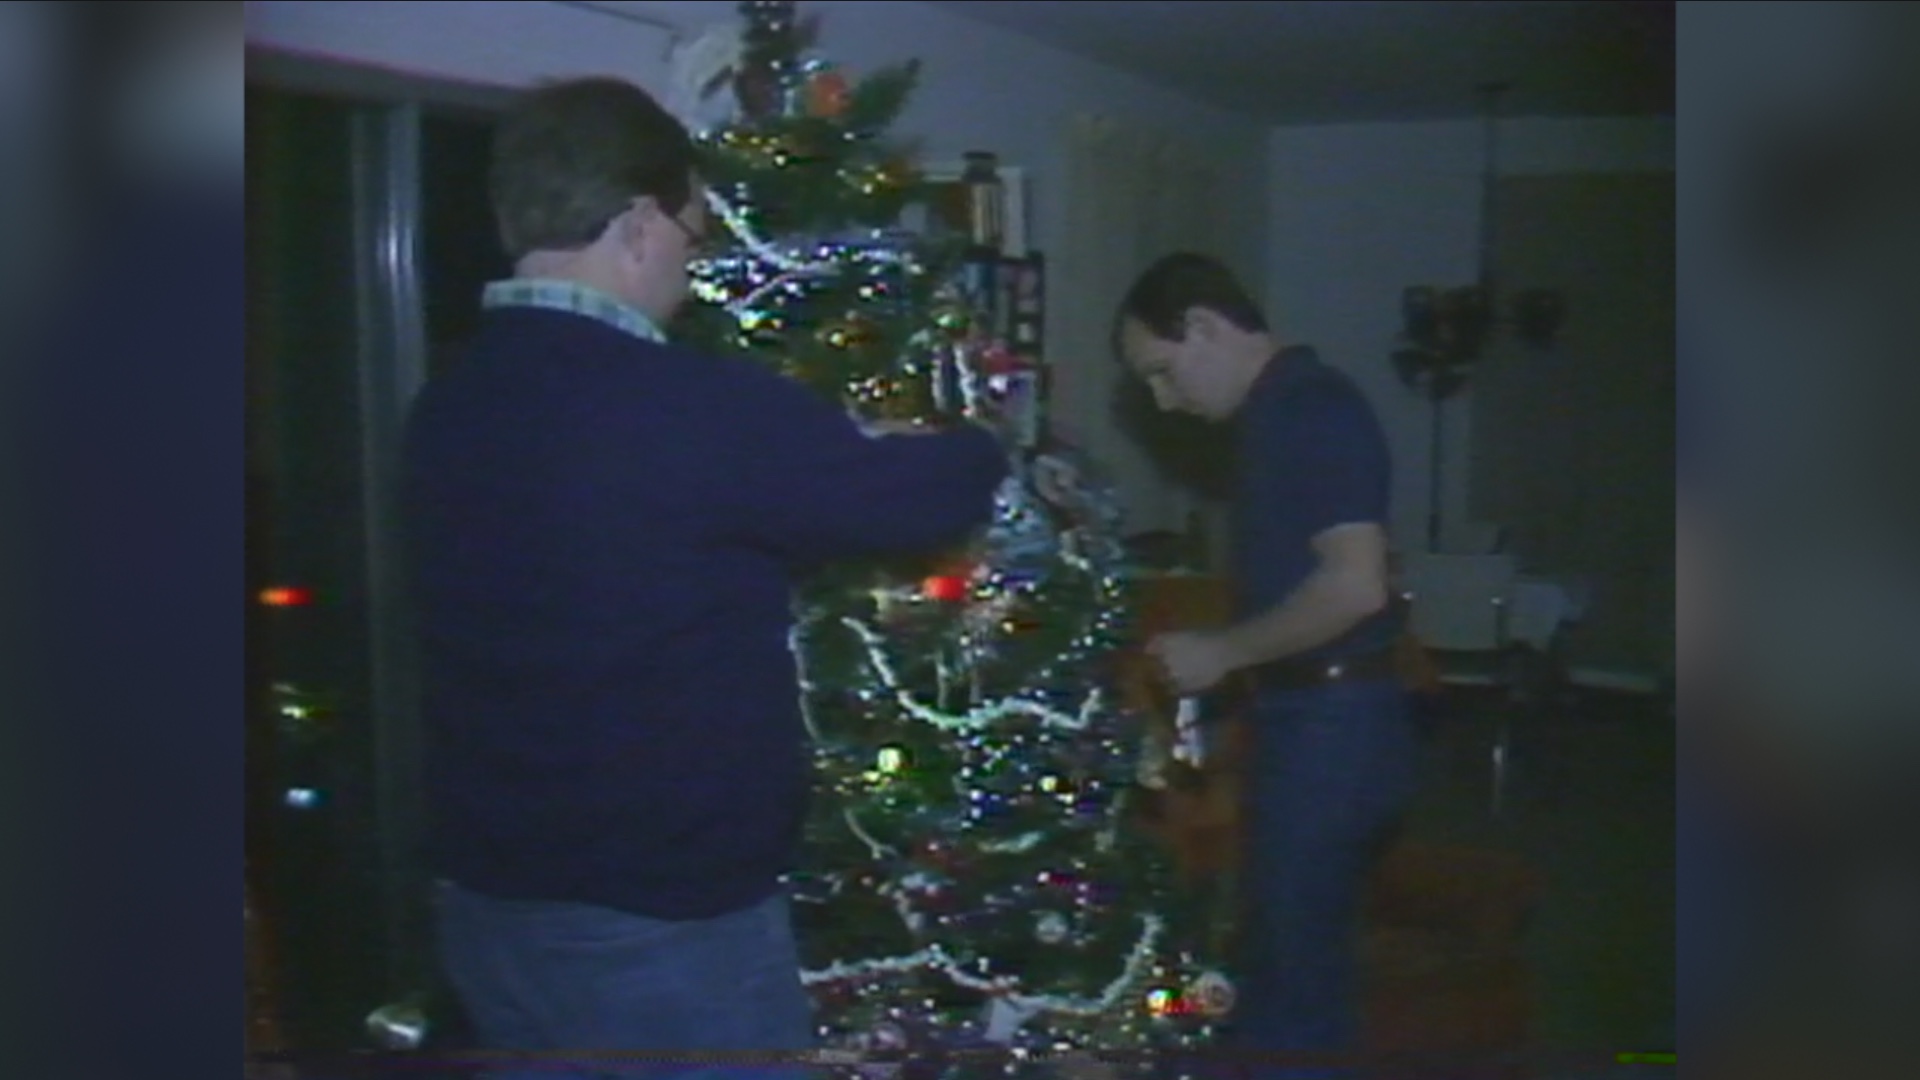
[913,0,1674,125]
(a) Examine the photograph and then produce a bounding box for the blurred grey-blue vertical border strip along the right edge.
[1678,0,1920,1076]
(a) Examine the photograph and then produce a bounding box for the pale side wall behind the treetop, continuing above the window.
[248,0,1269,518]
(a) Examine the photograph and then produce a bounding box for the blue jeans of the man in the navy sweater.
[436,882,814,1080]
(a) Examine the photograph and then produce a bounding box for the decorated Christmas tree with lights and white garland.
[676,0,1231,1053]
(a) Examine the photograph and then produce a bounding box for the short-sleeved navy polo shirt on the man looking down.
[1233,346,1400,659]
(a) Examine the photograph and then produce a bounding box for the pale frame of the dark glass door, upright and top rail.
[248,46,511,1038]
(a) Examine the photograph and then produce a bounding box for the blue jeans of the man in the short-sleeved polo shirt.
[1235,680,1421,1080]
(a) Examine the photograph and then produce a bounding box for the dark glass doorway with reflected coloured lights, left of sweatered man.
[246,58,511,1053]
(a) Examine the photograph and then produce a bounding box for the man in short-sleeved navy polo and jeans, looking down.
[1116,254,1417,1078]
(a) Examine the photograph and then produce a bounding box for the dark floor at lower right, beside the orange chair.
[1409,690,1674,1055]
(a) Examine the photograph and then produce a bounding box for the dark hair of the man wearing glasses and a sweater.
[488,77,695,259]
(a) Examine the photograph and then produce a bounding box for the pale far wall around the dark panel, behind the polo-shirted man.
[1267,119,1674,548]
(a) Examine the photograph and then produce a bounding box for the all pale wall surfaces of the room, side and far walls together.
[248,0,1674,564]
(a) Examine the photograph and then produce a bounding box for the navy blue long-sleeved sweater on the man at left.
[405,307,1006,919]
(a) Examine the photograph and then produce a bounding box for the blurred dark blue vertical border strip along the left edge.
[0,0,244,1078]
